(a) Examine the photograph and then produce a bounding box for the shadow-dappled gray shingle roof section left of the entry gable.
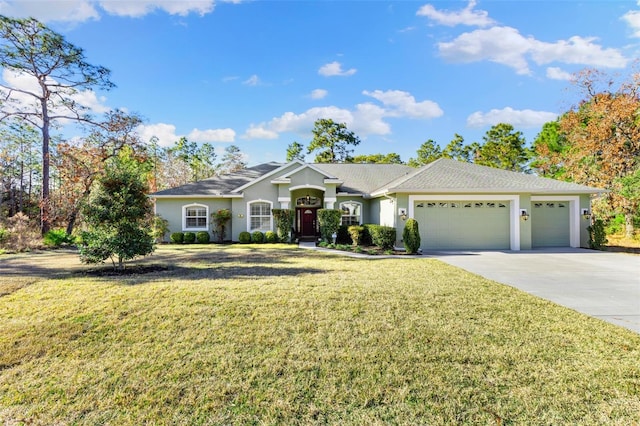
[151,163,282,197]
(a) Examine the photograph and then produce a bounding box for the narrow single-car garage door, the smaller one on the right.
[529,201,571,247]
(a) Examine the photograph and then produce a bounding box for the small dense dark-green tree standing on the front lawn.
[80,162,155,270]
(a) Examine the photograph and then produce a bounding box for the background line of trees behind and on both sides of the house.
[0,16,640,246]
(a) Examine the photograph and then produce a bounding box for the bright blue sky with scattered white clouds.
[0,0,640,165]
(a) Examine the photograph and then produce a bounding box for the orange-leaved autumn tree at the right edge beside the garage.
[552,69,640,237]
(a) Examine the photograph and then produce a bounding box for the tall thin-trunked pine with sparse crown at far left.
[0,16,114,233]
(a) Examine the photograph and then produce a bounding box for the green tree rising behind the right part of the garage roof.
[474,123,531,172]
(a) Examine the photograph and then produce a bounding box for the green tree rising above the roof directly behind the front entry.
[307,118,360,163]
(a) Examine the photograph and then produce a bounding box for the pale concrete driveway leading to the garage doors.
[436,248,640,333]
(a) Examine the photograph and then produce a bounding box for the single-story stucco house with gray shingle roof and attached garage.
[151,159,605,250]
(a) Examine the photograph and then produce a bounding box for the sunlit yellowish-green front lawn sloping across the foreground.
[0,245,640,425]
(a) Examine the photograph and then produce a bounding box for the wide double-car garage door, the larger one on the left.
[413,200,510,250]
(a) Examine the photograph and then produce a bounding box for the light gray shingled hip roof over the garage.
[380,158,606,193]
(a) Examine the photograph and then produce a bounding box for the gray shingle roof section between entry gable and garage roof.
[313,163,415,194]
